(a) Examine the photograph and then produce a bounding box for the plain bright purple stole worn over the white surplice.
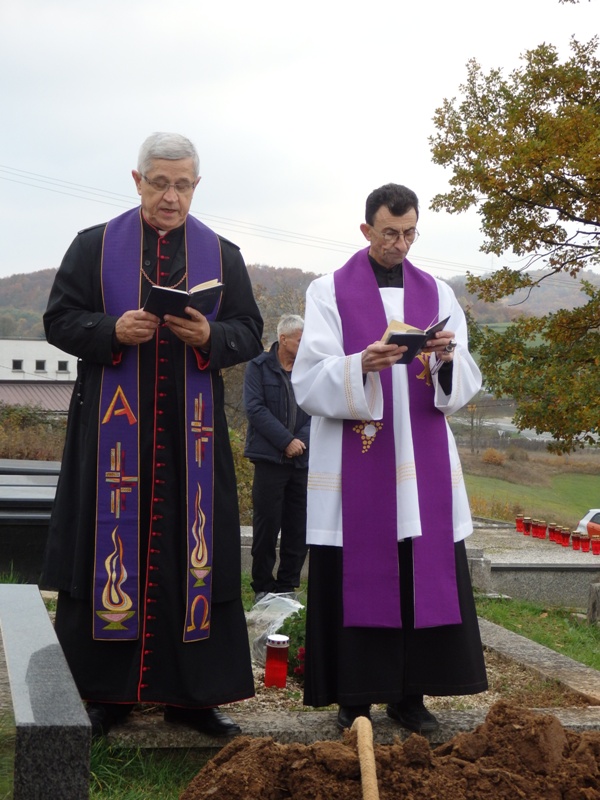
[334,247,461,628]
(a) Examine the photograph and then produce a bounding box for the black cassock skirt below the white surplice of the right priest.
[304,540,487,707]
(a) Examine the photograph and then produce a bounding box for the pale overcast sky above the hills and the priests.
[0,0,600,284]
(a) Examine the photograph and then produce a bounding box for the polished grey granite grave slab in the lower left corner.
[0,584,91,800]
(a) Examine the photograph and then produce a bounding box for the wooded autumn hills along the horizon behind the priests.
[0,264,600,341]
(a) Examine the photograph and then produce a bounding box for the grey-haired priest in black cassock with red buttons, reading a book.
[43,133,262,736]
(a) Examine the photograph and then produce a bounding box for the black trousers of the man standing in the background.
[252,461,308,592]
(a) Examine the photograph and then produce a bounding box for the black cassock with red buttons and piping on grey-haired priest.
[42,217,263,707]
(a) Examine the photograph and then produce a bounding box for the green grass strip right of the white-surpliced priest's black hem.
[476,597,600,669]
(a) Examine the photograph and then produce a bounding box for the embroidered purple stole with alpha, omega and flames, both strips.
[93,208,221,642]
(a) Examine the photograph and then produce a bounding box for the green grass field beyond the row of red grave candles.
[465,473,600,527]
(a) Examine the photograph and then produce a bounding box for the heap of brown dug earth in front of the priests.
[180,702,600,800]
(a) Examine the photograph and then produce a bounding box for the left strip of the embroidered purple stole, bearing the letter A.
[93,209,142,641]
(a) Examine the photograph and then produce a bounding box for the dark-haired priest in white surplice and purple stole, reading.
[292,184,487,733]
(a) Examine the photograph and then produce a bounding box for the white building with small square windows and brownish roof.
[0,339,77,412]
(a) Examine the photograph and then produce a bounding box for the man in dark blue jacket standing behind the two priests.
[244,314,310,601]
